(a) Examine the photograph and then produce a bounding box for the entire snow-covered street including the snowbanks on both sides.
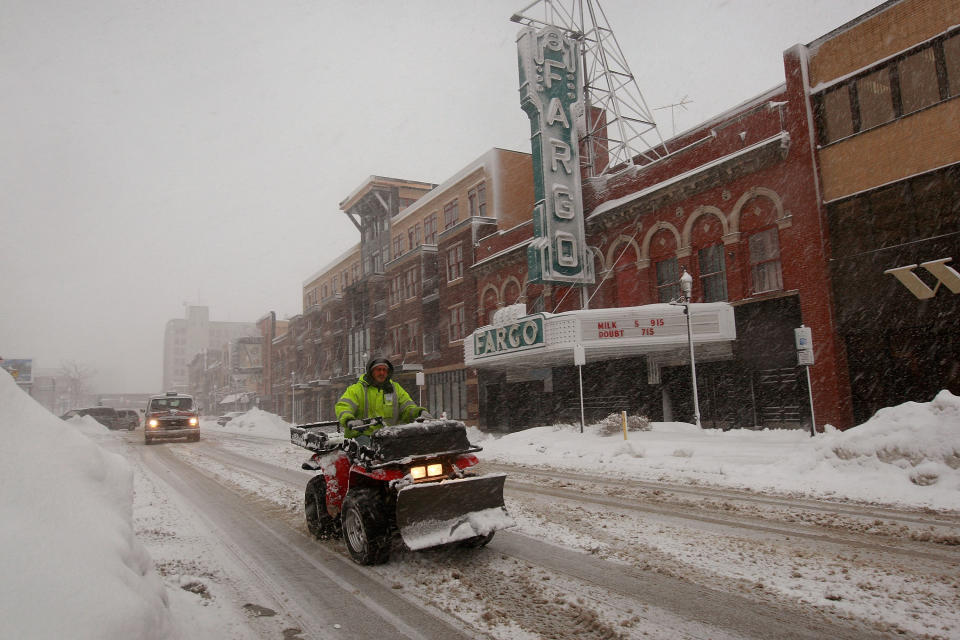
[0,368,960,640]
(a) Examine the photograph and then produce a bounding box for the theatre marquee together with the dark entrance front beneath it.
[464,302,736,430]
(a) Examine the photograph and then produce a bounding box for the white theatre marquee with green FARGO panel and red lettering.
[463,302,737,369]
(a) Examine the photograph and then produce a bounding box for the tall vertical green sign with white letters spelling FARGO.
[517,26,594,285]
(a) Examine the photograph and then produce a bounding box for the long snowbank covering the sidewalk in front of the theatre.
[478,391,960,510]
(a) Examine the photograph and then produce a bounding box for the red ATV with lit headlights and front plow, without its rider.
[290,419,514,565]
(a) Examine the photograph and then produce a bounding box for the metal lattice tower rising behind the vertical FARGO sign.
[510,0,667,176]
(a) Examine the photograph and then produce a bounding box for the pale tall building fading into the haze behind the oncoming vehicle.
[163,306,259,393]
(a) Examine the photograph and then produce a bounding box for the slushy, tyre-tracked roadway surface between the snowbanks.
[104,426,960,640]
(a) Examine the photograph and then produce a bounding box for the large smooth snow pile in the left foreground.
[0,371,172,639]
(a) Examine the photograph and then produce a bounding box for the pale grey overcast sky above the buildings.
[0,0,879,392]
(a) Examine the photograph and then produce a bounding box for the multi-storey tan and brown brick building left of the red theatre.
[272,149,533,421]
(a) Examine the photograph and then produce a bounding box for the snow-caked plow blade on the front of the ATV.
[397,473,515,551]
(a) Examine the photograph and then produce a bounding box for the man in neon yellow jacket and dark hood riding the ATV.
[336,358,433,438]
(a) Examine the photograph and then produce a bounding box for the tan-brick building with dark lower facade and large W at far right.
[802,0,960,422]
